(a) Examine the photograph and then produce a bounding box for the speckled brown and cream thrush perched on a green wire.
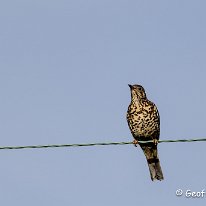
[127,84,164,181]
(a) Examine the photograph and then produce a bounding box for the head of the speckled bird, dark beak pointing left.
[128,84,147,101]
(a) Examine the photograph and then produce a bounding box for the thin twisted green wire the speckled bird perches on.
[0,138,206,150]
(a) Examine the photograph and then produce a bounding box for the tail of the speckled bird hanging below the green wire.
[141,144,164,181]
